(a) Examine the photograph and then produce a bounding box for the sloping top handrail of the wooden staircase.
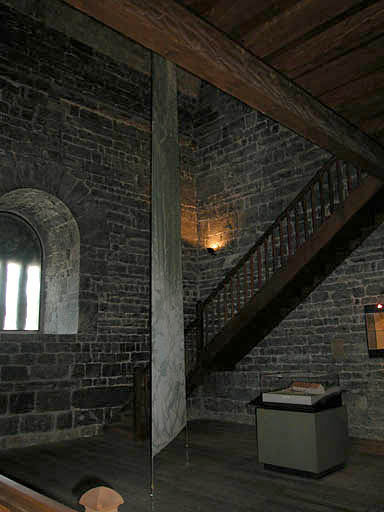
[202,157,337,307]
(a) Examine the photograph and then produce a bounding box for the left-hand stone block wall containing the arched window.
[0,3,197,448]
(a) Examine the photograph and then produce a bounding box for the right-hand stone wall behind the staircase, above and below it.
[190,84,384,439]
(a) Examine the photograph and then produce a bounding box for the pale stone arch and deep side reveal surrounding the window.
[0,188,80,334]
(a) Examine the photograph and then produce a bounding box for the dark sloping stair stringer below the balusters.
[187,176,384,394]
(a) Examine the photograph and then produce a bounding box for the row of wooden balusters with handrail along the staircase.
[186,159,381,388]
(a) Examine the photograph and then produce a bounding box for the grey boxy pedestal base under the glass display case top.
[257,404,348,478]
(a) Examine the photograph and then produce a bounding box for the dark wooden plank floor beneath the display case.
[0,421,384,512]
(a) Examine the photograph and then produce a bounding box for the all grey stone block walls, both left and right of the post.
[0,0,384,448]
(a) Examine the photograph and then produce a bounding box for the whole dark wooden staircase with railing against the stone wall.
[185,159,384,394]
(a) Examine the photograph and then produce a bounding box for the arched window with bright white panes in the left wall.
[0,212,42,331]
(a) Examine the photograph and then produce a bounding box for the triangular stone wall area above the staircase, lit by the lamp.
[195,83,330,299]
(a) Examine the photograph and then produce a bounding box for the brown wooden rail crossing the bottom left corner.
[0,475,77,512]
